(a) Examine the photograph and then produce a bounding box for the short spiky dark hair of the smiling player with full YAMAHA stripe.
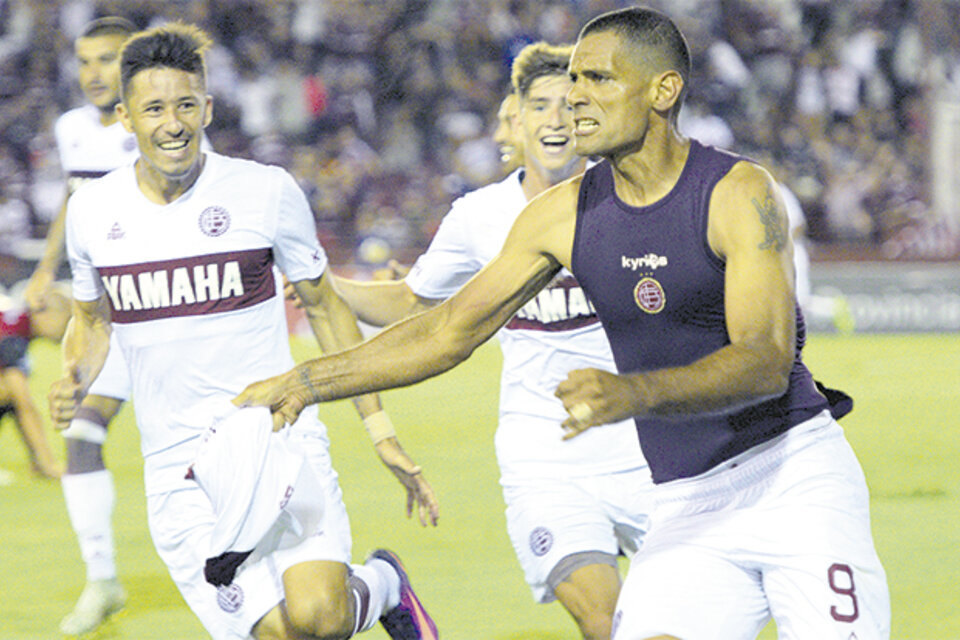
[120,22,213,93]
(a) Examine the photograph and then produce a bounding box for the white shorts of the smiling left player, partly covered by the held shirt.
[147,422,351,640]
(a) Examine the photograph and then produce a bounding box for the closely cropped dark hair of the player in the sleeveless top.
[580,7,690,93]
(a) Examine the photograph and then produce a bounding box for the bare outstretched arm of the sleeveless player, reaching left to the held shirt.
[235,183,577,422]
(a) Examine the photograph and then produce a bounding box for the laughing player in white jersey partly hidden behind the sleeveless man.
[337,42,652,639]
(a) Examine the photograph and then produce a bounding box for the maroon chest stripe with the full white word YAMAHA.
[97,247,276,324]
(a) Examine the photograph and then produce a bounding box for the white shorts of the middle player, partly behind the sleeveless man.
[503,468,653,603]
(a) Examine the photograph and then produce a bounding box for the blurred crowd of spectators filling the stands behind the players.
[0,0,960,277]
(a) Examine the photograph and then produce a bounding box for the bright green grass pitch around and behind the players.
[0,334,960,640]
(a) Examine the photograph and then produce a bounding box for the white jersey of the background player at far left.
[53,104,140,193]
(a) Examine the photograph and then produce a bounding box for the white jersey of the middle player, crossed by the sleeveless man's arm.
[406,170,646,481]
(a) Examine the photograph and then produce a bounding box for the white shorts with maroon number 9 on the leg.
[612,413,890,640]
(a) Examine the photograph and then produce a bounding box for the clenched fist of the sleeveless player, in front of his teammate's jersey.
[554,369,636,440]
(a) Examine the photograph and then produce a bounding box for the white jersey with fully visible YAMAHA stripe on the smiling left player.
[67,153,327,494]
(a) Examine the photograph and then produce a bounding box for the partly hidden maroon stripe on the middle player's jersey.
[506,276,599,331]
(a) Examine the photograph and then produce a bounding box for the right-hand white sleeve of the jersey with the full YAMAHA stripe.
[274,170,327,282]
